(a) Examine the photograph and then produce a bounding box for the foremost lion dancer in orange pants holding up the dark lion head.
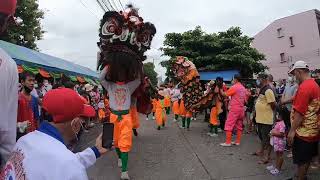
[98,5,156,179]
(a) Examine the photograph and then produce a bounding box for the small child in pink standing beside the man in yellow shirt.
[267,110,286,175]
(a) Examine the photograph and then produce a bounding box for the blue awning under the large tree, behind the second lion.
[199,70,239,81]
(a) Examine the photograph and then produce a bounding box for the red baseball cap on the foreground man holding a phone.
[43,88,95,123]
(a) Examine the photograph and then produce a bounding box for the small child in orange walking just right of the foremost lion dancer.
[155,94,167,130]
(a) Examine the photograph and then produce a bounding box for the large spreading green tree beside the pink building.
[161,26,267,77]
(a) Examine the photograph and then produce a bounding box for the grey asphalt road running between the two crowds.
[75,115,320,180]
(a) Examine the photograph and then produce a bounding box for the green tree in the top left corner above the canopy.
[1,0,44,50]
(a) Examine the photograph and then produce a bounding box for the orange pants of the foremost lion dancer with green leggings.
[110,113,132,152]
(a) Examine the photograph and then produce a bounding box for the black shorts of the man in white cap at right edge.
[292,137,318,165]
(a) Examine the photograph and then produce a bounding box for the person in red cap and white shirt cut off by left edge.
[0,0,18,167]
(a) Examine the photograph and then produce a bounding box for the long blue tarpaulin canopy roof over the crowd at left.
[0,40,98,78]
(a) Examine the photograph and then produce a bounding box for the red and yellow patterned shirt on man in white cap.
[293,79,320,141]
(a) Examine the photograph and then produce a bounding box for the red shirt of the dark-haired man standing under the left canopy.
[17,93,36,132]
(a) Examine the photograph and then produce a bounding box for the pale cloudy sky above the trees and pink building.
[38,0,320,78]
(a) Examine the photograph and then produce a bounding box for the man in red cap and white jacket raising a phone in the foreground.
[0,88,107,180]
